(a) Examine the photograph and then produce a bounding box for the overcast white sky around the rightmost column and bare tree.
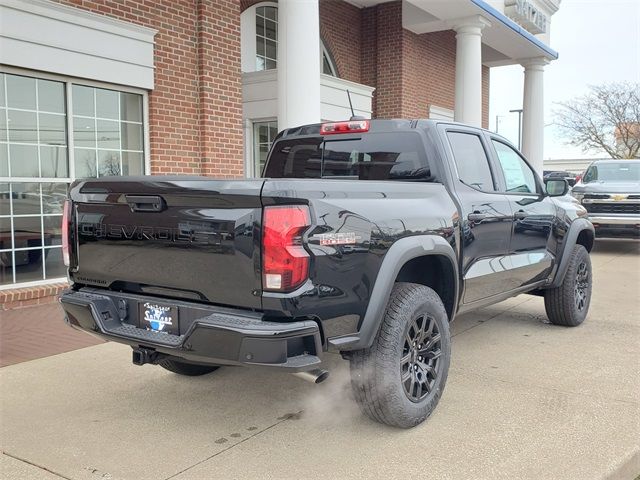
[489,0,640,159]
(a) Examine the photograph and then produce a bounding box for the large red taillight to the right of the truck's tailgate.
[262,205,311,292]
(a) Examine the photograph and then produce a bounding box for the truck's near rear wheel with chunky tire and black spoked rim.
[350,283,451,428]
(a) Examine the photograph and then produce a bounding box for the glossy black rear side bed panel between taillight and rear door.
[262,179,457,337]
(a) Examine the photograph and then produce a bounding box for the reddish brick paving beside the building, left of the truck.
[0,303,103,367]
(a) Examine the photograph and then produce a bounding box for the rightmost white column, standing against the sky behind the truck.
[522,58,548,174]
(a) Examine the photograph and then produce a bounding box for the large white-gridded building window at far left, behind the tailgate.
[0,72,144,286]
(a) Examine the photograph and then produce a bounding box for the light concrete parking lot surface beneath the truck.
[0,241,640,480]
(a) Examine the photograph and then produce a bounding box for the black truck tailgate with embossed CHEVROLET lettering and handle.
[70,177,264,308]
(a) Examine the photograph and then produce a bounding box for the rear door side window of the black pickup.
[447,132,495,192]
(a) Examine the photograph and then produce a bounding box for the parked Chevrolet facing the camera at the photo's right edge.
[571,159,640,237]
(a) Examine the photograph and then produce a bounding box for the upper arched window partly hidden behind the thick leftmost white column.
[240,2,338,77]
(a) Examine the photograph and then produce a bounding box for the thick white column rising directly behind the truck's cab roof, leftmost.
[277,0,320,130]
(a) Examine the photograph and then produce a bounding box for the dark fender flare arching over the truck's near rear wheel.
[329,235,460,351]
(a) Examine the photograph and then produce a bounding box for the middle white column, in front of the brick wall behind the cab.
[453,15,490,127]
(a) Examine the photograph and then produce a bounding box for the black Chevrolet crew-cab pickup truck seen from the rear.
[61,119,594,427]
